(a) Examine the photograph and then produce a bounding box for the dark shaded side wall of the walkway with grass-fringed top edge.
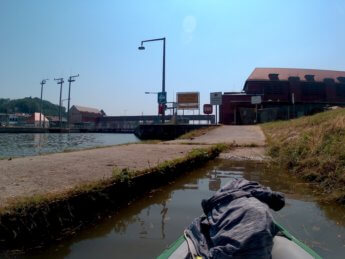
[0,145,226,254]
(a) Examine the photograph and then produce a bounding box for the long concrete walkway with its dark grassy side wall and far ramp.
[0,126,264,254]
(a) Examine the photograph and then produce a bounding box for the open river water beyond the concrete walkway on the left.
[0,133,139,158]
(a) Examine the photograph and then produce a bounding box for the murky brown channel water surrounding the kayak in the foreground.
[19,160,345,259]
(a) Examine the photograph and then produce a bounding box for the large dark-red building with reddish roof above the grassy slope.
[220,68,345,124]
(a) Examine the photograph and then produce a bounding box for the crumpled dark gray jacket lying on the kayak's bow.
[185,179,285,259]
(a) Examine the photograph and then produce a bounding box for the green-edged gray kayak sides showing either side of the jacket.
[157,222,322,259]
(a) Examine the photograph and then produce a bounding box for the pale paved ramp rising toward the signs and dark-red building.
[167,125,265,146]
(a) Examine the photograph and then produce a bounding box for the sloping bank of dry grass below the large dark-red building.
[262,108,345,204]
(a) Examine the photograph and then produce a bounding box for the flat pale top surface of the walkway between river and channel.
[0,144,204,207]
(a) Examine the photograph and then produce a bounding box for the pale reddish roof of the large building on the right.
[247,68,345,83]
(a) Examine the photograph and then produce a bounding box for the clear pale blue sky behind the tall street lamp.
[0,0,345,115]
